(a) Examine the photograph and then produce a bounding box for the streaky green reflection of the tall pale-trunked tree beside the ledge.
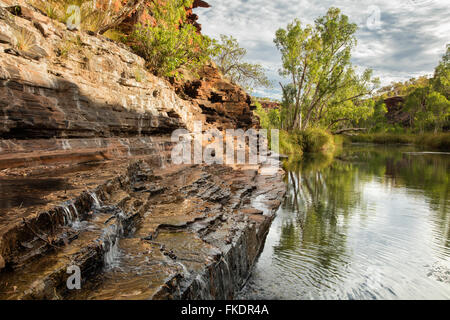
[274,156,361,290]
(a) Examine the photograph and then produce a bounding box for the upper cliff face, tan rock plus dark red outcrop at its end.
[0,2,252,168]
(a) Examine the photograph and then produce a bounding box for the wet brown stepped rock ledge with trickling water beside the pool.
[0,160,285,299]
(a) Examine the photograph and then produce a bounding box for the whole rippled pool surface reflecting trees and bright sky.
[240,145,450,299]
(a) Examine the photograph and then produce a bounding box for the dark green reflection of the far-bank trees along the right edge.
[341,146,450,248]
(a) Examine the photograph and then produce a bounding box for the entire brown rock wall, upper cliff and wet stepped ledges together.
[0,0,284,299]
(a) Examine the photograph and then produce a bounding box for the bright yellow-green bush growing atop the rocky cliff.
[127,0,214,77]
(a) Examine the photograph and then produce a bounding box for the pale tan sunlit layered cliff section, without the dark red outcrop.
[0,4,200,138]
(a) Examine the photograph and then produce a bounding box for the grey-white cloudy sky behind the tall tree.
[196,0,450,98]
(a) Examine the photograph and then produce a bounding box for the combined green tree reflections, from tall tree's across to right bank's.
[274,146,450,292]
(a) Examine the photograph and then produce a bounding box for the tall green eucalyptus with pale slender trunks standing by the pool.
[274,8,378,130]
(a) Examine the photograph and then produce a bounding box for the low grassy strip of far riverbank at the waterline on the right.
[344,132,450,151]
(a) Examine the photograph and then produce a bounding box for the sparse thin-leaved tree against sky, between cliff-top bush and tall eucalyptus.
[213,35,271,90]
